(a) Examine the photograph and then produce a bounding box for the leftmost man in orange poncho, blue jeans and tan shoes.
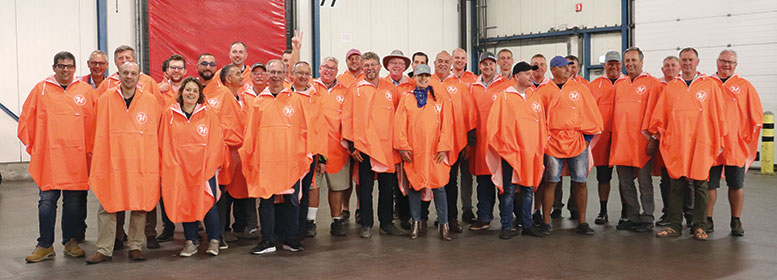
[17,51,97,262]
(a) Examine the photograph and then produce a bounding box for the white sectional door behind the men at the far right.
[634,0,777,166]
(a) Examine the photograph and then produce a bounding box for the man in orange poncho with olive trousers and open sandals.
[643,48,728,240]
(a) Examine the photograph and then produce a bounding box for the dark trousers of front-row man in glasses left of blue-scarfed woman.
[359,153,397,227]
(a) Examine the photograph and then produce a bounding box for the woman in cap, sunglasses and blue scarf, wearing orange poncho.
[394,64,457,240]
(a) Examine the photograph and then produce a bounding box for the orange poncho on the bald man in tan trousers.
[89,86,161,213]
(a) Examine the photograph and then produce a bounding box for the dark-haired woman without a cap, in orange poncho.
[159,77,227,257]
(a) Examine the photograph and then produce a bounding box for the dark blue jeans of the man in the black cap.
[499,159,534,229]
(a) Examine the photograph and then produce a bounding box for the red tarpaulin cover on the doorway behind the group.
[148,0,286,81]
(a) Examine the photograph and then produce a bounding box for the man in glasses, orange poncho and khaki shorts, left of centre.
[308,56,352,236]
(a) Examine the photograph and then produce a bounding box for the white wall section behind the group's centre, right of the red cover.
[316,0,458,75]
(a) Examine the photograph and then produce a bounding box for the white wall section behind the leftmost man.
[0,0,97,162]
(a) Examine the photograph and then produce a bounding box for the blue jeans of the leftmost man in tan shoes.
[38,190,87,248]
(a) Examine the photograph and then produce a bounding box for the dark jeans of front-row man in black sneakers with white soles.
[259,180,302,242]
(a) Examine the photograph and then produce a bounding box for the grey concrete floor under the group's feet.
[0,172,777,279]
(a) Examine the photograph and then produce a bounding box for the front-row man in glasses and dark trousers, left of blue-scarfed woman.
[342,52,402,238]
